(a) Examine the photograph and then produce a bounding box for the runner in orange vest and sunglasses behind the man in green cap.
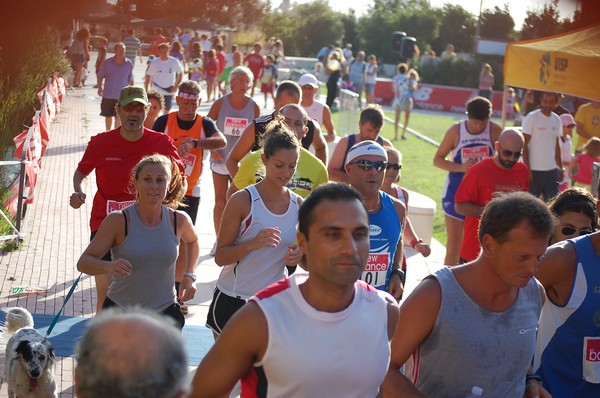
[152,80,226,314]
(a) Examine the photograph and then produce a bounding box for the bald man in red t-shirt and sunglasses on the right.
[454,129,529,264]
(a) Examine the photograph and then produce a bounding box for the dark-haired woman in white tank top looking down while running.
[207,118,302,333]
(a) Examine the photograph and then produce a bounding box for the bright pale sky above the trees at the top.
[282,0,576,30]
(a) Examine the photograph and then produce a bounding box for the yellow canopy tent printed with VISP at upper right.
[502,25,600,121]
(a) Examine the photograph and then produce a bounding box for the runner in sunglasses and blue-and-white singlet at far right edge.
[533,188,600,397]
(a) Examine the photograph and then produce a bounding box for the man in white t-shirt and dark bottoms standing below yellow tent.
[523,92,565,202]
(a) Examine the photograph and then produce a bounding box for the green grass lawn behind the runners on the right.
[333,111,499,245]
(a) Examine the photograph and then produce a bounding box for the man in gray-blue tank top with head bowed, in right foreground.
[383,192,553,397]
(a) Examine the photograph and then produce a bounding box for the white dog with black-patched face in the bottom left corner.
[3,307,57,398]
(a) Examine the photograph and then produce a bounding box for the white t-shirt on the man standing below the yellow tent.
[523,109,562,171]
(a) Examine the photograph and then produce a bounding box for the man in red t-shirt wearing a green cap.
[69,86,185,312]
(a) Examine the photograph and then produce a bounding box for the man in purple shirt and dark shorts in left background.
[98,43,133,130]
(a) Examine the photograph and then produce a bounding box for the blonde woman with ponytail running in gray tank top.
[77,154,200,329]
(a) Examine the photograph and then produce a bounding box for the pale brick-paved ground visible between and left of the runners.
[0,54,444,398]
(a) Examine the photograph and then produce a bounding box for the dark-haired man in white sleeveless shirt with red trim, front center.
[190,183,398,398]
